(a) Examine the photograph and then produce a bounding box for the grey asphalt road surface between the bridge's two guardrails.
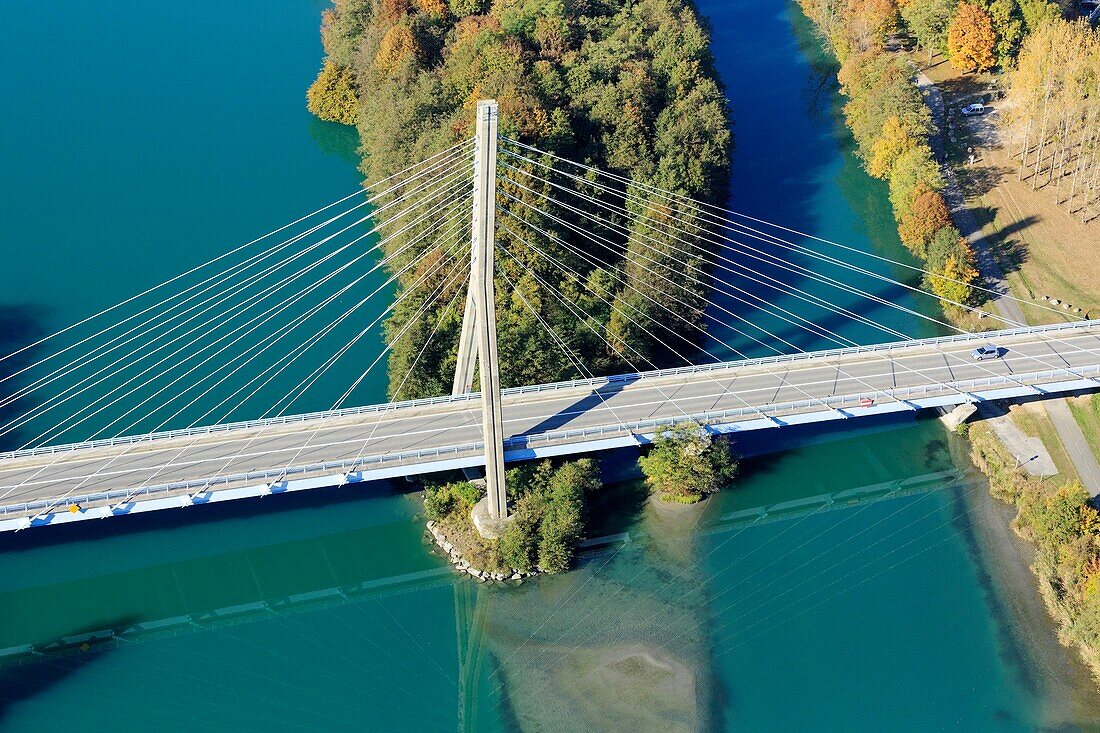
[0,325,1100,506]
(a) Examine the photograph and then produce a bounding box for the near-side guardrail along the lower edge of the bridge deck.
[0,364,1100,516]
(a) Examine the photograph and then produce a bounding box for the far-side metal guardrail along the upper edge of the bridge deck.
[0,320,1100,461]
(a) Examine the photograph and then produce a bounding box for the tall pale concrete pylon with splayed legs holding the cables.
[452,100,508,534]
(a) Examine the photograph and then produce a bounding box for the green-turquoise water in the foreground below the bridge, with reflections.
[0,422,1095,731]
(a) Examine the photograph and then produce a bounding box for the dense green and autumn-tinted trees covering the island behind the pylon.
[310,0,733,398]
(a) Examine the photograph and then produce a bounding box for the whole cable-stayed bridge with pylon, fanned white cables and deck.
[0,98,1100,529]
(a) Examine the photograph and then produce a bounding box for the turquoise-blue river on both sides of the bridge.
[0,0,1100,732]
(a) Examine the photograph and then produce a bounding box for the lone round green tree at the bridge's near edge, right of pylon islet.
[639,423,737,504]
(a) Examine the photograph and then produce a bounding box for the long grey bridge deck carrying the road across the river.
[0,321,1100,518]
